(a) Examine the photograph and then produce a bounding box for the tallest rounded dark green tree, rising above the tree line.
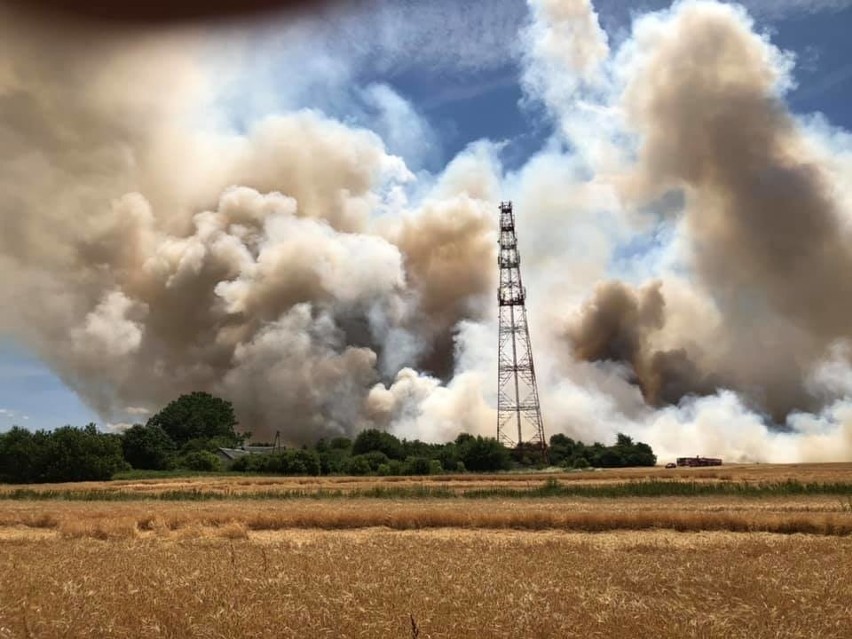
[147,392,241,446]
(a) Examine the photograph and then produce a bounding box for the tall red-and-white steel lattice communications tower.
[497,202,546,454]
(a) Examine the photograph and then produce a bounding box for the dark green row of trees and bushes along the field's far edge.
[0,393,656,483]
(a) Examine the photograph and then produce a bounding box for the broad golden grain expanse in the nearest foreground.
[0,529,852,639]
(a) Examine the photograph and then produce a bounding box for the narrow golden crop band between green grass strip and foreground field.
[0,496,852,539]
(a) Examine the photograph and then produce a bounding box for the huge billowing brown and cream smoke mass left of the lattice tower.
[0,5,494,442]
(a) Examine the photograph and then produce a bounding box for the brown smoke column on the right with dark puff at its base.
[569,2,852,421]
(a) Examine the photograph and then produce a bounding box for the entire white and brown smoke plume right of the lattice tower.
[512,1,852,461]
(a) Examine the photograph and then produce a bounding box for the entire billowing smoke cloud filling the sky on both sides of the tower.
[0,0,852,461]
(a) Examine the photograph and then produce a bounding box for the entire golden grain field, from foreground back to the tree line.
[0,464,852,639]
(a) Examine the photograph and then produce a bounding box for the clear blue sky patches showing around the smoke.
[0,0,852,430]
